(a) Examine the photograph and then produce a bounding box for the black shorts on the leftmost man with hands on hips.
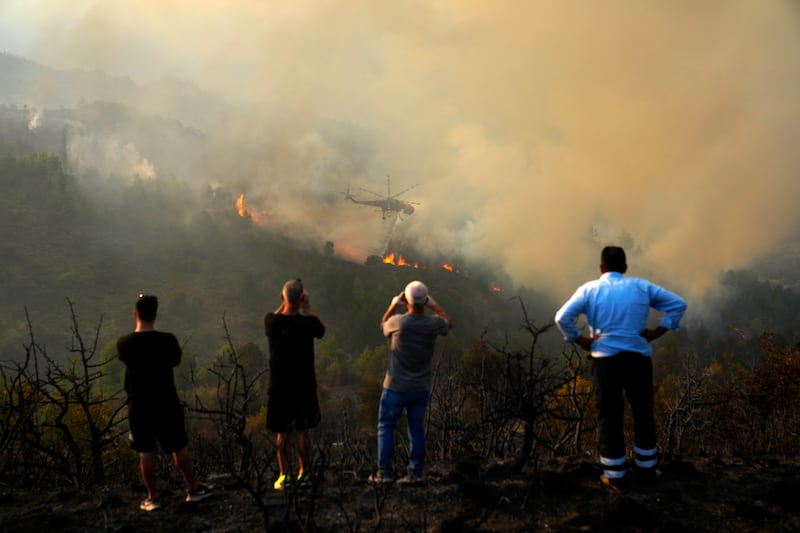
[128,403,189,453]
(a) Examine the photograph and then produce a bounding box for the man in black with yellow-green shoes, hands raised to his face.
[264,279,325,490]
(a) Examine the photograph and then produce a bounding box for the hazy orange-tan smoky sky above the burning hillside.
[0,0,800,299]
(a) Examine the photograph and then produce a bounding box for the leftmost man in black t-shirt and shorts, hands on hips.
[117,294,211,511]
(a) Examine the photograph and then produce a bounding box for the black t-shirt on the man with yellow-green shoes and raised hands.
[264,313,325,397]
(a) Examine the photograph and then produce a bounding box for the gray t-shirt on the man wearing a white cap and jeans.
[383,313,450,392]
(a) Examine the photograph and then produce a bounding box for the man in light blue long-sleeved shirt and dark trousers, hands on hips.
[555,246,686,486]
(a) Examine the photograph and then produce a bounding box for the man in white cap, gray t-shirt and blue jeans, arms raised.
[370,281,452,483]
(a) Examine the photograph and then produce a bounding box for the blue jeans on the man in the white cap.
[378,389,430,477]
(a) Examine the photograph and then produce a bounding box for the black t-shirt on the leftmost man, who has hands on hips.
[117,331,181,406]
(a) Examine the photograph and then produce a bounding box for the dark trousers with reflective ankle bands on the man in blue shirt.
[592,352,656,471]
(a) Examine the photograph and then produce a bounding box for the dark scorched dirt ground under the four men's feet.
[0,458,800,533]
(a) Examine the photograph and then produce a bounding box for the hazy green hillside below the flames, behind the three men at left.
[0,148,536,361]
